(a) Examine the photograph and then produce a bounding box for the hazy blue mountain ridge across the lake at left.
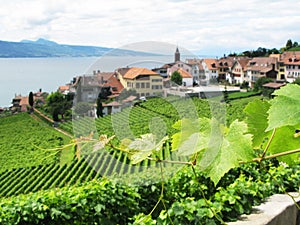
[0,38,157,58]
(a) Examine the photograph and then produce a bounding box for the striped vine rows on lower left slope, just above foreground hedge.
[0,144,183,197]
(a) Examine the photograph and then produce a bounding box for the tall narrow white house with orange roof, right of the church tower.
[202,59,219,85]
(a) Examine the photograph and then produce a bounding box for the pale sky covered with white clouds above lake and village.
[0,0,300,56]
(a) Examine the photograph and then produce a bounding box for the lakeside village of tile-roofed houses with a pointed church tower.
[7,47,300,116]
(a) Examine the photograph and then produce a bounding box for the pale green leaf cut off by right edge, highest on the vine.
[267,84,300,131]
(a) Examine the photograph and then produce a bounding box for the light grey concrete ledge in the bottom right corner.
[227,193,300,225]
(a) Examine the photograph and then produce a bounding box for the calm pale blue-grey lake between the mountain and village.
[0,56,173,107]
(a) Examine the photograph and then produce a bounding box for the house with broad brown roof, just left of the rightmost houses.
[246,57,278,87]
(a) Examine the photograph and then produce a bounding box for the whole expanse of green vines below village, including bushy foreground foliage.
[0,90,299,225]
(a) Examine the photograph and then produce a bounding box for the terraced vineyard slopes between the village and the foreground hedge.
[0,97,255,196]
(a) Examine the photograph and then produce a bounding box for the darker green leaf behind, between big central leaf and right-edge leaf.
[244,99,270,148]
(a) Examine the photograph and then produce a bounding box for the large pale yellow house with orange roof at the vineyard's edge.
[116,67,163,97]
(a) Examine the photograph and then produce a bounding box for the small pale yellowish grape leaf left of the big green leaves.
[122,134,168,164]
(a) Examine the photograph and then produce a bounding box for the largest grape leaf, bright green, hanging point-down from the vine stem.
[200,120,254,185]
